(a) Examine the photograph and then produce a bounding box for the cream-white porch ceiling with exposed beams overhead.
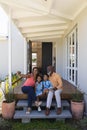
[0,0,87,41]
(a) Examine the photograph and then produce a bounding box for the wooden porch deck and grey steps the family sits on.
[14,79,79,123]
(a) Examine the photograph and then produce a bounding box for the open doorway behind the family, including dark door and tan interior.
[29,42,53,74]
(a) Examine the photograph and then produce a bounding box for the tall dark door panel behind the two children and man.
[42,42,52,74]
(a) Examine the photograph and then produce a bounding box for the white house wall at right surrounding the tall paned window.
[63,8,87,93]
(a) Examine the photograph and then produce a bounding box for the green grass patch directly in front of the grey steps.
[11,119,77,130]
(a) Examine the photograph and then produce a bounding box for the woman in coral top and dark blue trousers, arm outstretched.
[19,67,38,114]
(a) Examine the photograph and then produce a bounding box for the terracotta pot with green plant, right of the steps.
[71,87,84,120]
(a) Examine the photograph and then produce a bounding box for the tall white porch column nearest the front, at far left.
[8,9,12,88]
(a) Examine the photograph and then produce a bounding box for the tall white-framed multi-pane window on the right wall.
[66,26,78,85]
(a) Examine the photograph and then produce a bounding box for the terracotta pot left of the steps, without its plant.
[2,101,15,119]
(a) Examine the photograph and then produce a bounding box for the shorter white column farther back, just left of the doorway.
[24,38,27,74]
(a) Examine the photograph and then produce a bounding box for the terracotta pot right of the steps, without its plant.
[71,101,84,120]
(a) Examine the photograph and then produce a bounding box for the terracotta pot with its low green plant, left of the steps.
[2,88,15,119]
